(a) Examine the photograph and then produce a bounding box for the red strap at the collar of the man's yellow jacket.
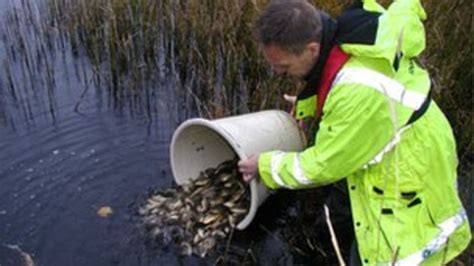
[316,45,350,118]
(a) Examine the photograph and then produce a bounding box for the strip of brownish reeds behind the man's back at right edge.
[424,0,474,176]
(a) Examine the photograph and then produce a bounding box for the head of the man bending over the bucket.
[254,0,322,78]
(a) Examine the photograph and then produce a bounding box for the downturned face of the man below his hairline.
[263,42,319,79]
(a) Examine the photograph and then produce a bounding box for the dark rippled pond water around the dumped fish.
[0,0,300,266]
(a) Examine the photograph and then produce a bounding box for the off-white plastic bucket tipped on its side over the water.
[170,110,305,230]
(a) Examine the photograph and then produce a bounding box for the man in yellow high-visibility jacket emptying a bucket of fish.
[239,0,471,265]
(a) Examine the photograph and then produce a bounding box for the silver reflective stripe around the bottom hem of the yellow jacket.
[387,209,467,266]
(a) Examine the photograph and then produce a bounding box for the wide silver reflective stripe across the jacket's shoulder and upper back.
[333,68,426,110]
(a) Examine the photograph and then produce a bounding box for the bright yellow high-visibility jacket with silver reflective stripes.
[258,0,471,265]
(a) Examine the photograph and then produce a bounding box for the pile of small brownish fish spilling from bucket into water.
[139,160,250,257]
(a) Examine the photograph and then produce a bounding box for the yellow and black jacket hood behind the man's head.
[336,0,426,70]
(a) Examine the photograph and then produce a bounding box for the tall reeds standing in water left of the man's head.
[44,0,296,117]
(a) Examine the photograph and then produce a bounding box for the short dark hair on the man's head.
[253,0,323,54]
